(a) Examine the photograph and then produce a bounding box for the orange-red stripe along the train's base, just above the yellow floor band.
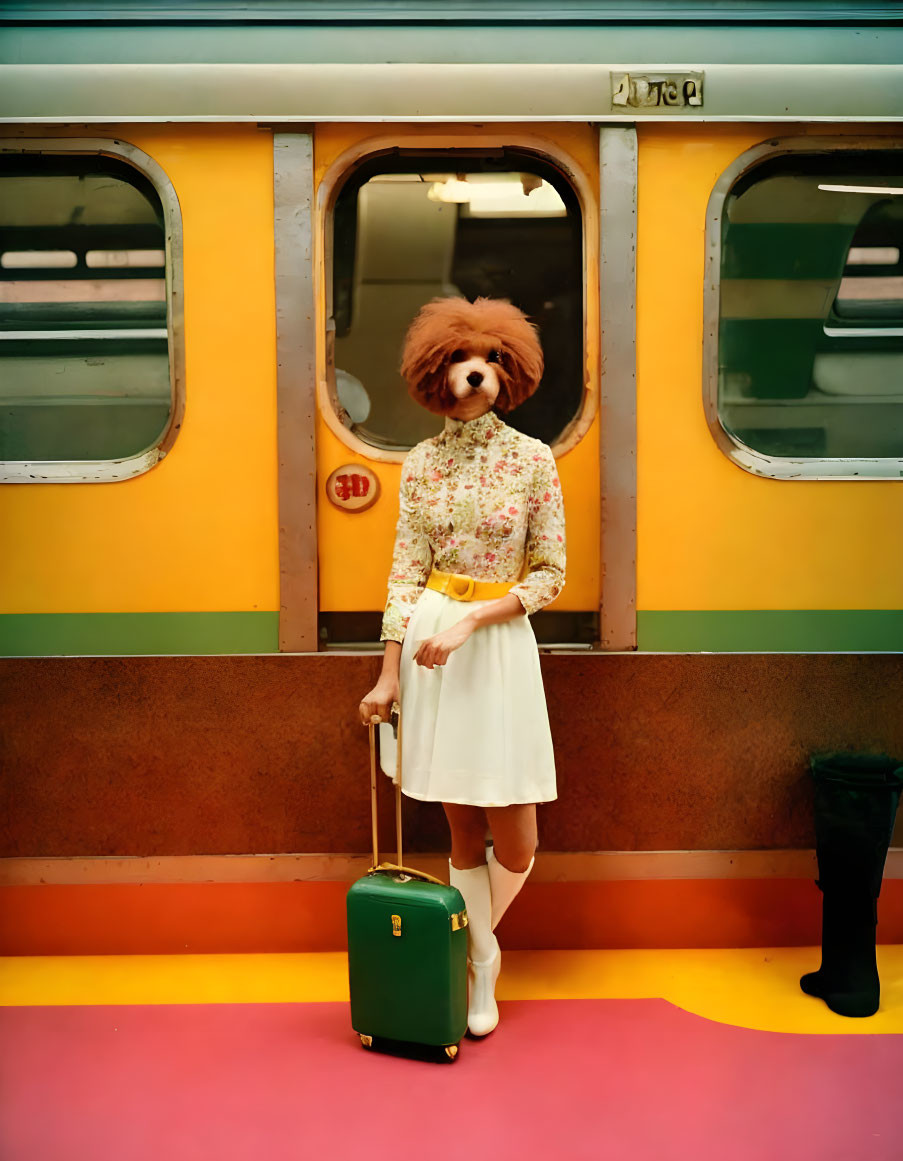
[0,879,903,956]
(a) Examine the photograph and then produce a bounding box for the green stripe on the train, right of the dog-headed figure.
[636,610,903,652]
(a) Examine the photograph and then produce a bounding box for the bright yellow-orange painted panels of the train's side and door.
[7,123,903,652]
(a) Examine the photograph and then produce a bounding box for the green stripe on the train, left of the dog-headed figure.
[0,612,279,657]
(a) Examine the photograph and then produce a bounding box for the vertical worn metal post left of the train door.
[273,129,319,652]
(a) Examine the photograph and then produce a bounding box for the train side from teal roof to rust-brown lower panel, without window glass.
[0,2,903,942]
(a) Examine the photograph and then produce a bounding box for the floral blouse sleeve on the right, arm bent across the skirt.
[511,446,565,615]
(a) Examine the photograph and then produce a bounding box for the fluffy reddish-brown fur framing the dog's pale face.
[402,298,542,416]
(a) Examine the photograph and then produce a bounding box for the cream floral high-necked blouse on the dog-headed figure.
[381,411,565,641]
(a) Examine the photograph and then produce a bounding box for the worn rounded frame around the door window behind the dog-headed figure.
[317,130,599,463]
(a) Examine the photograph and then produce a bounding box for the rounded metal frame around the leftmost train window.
[0,137,185,484]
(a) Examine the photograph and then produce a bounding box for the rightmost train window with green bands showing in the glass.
[709,142,903,478]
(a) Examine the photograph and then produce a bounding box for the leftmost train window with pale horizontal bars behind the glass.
[0,142,183,479]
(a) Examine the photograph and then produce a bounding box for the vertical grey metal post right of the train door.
[599,125,637,651]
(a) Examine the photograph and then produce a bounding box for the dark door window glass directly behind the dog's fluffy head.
[332,150,584,454]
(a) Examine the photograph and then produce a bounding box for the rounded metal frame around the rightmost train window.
[702,136,903,481]
